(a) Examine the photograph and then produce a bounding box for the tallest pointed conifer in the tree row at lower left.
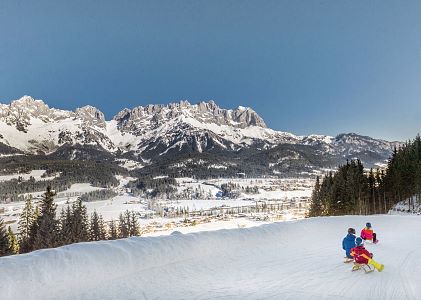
[33,186,60,250]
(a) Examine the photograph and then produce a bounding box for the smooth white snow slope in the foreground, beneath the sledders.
[0,216,421,299]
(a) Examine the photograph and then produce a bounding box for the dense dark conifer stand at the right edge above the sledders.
[308,135,421,217]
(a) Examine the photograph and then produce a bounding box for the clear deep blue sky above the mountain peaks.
[0,0,421,140]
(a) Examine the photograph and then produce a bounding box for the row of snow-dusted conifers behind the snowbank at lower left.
[0,187,140,256]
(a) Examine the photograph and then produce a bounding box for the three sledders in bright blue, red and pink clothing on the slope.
[342,223,384,273]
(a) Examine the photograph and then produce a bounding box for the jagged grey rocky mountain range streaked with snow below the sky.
[0,96,398,173]
